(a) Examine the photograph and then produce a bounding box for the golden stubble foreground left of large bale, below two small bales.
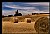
[2,23,34,32]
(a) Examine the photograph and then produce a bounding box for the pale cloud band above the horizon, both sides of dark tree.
[2,10,49,15]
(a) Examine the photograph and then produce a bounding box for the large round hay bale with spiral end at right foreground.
[34,17,49,32]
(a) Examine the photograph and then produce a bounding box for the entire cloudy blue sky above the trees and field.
[2,2,49,15]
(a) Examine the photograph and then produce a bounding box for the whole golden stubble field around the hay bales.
[2,14,49,34]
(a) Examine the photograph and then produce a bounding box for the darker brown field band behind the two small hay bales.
[2,14,48,22]
